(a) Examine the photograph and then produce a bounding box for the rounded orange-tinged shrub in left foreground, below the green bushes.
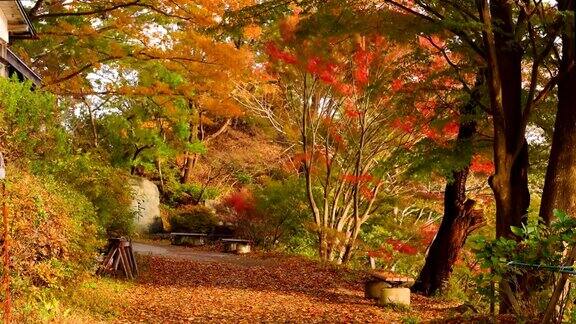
[2,169,103,294]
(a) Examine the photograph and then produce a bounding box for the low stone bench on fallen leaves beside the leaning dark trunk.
[364,271,414,306]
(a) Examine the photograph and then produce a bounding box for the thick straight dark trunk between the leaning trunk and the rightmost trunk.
[478,0,530,313]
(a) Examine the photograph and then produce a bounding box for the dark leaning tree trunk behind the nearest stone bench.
[412,78,484,296]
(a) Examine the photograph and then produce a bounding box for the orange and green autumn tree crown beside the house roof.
[19,0,251,185]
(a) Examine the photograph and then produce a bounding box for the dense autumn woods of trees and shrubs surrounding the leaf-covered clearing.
[0,0,576,323]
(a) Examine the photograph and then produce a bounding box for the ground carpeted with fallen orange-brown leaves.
[109,244,464,323]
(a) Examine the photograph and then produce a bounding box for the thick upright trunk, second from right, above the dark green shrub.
[490,0,530,237]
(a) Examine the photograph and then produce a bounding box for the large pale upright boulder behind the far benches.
[130,177,161,233]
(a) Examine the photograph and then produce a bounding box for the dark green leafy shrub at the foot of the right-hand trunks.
[474,211,576,317]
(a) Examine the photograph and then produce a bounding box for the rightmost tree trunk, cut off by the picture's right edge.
[540,0,576,224]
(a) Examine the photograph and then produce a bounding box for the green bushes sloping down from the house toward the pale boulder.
[0,78,134,235]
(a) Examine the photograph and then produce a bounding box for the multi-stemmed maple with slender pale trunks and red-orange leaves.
[237,8,476,262]
